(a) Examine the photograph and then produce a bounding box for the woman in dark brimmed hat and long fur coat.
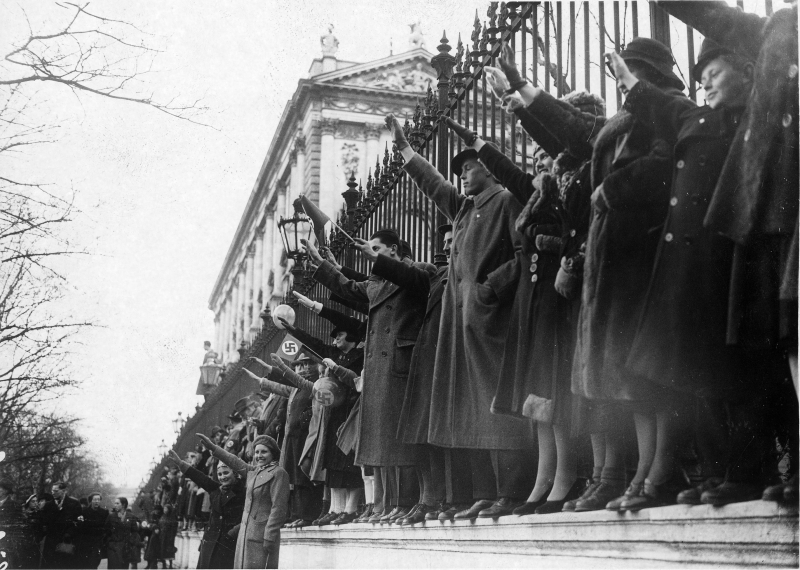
[572,38,695,511]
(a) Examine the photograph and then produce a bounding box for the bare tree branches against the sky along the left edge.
[0,2,205,478]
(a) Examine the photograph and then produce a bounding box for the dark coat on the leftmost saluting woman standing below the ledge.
[181,465,245,568]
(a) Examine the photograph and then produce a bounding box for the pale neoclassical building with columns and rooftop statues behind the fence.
[209,28,436,363]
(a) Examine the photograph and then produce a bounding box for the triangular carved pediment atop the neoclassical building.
[314,48,436,93]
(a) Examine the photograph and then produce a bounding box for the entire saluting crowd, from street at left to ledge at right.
[0,2,799,568]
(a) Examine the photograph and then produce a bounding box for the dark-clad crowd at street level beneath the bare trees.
[0,479,178,569]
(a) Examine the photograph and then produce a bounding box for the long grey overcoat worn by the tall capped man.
[403,155,531,449]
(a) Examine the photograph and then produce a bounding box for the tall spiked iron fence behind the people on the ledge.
[145,0,772,489]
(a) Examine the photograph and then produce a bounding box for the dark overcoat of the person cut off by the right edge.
[662,2,800,350]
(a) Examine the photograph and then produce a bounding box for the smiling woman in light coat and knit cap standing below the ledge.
[197,433,289,568]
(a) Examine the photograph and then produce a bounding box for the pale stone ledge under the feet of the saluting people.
[281,501,798,569]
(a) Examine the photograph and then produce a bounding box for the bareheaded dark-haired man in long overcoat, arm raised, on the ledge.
[303,229,436,523]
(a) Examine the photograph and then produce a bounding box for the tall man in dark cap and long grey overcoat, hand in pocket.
[386,115,535,519]
